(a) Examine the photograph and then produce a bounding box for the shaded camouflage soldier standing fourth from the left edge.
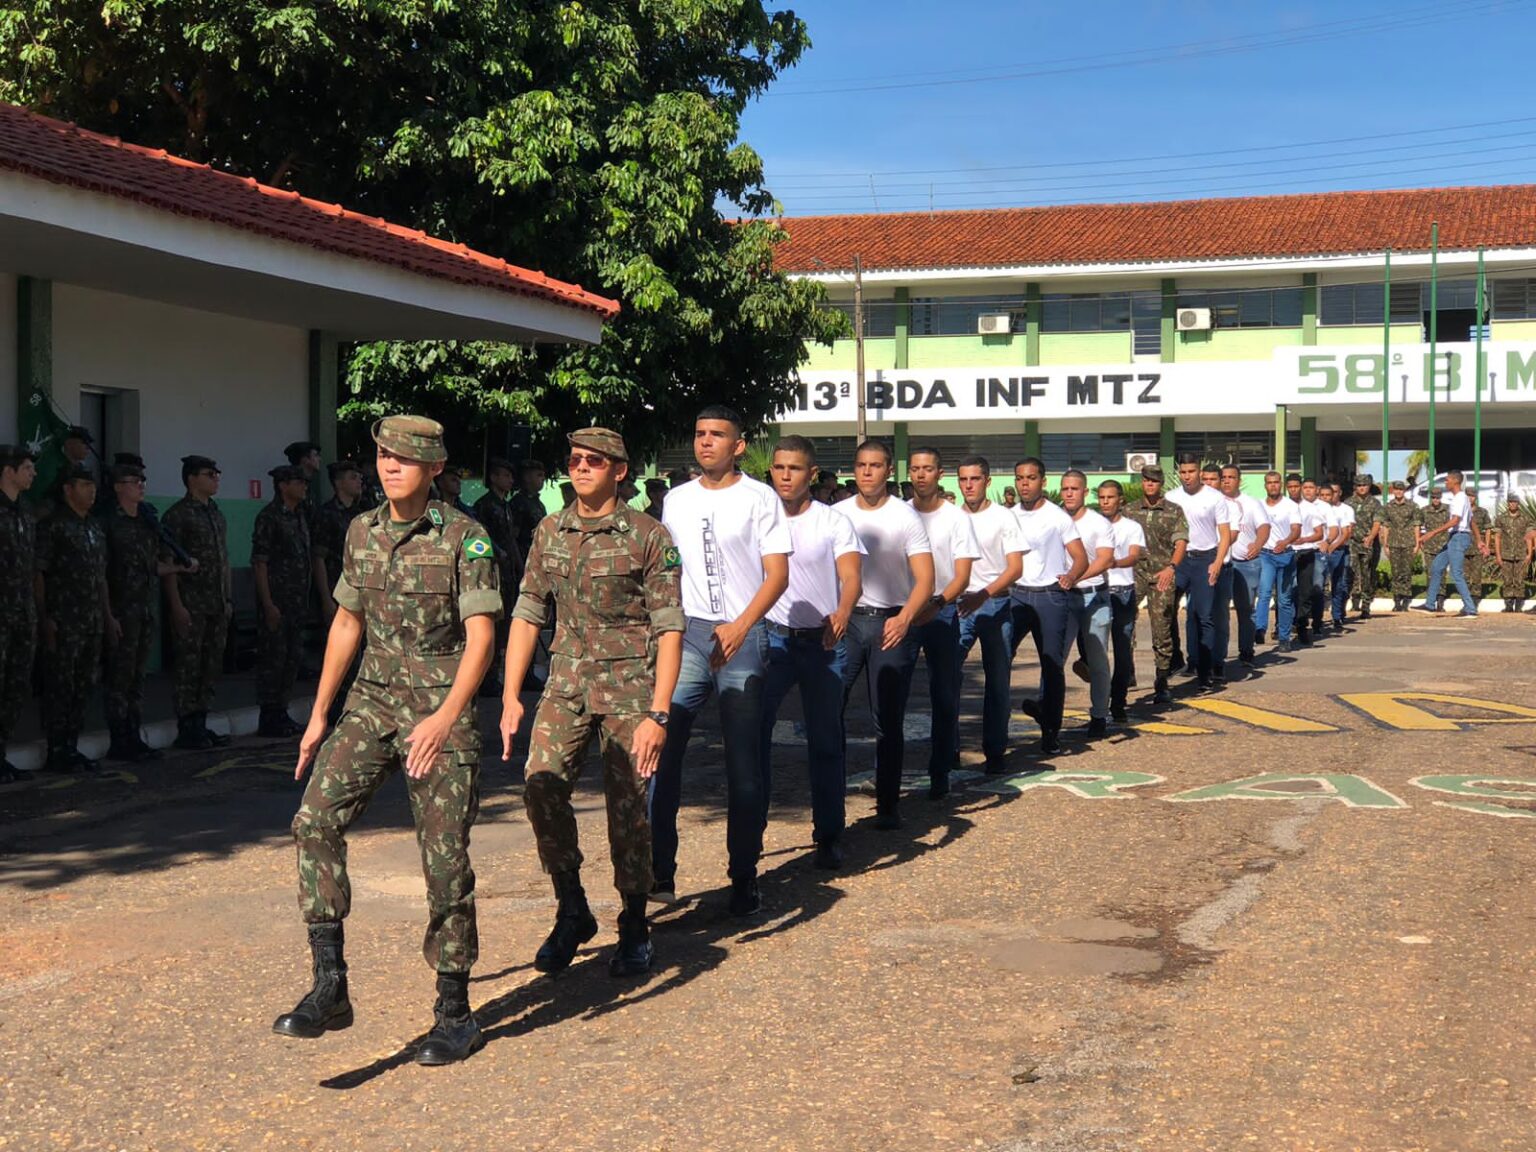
[160,456,233,750]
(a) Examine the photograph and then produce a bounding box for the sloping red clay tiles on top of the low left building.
[0,103,619,316]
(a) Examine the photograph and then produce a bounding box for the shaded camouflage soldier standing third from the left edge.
[101,464,177,760]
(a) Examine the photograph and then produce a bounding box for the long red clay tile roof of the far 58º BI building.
[776,184,1536,272]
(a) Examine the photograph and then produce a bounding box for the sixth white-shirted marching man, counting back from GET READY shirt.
[1012,456,1087,756]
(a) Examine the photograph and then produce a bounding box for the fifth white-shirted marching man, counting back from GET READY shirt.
[955,456,1025,776]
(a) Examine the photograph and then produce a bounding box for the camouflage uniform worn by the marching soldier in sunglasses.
[513,502,684,895]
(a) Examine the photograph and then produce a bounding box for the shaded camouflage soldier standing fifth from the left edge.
[250,464,313,737]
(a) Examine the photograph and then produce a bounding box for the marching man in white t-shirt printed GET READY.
[651,404,791,915]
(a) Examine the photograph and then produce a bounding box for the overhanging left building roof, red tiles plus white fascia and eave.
[0,104,619,344]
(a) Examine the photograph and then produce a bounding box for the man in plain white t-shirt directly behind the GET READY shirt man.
[762,436,863,868]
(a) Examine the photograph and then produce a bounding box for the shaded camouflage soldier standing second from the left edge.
[35,464,115,773]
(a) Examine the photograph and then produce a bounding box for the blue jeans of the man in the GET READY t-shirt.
[650,619,768,883]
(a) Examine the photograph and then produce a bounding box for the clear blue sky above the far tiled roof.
[742,0,1536,215]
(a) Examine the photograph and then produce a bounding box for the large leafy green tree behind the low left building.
[0,0,842,463]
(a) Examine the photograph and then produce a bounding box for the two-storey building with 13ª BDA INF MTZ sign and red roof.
[777,184,1536,492]
